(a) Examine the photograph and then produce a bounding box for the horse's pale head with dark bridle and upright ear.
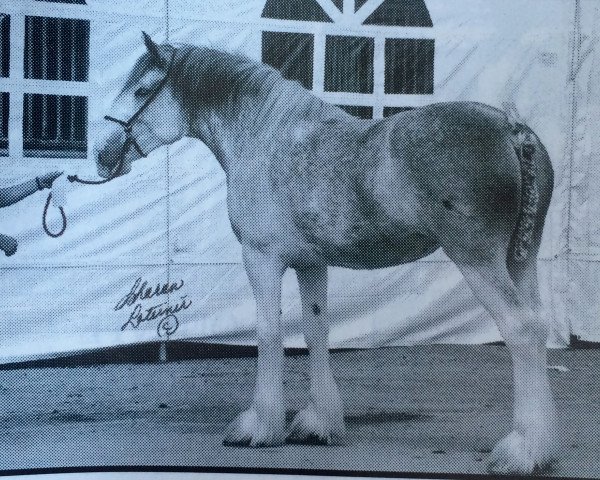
[95,33,186,178]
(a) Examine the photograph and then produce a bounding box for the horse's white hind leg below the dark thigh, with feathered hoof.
[449,252,557,474]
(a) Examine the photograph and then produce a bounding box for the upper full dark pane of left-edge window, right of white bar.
[25,17,90,82]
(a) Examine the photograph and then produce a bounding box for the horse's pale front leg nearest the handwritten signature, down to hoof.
[223,247,285,447]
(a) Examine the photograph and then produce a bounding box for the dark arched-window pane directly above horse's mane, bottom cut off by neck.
[262,32,314,89]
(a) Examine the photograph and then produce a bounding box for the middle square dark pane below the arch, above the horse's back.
[325,36,375,93]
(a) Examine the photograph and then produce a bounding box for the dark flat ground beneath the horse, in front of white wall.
[0,346,600,478]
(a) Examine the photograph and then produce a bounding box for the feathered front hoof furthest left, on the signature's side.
[223,408,284,447]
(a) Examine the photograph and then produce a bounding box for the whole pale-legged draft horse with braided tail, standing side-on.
[94,33,559,474]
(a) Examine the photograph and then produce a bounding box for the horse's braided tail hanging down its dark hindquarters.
[513,124,539,262]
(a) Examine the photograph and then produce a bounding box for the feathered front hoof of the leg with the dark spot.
[286,406,345,445]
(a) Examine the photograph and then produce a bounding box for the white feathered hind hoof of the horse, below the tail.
[487,431,554,475]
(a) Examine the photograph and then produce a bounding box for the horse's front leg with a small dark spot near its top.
[287,267,344,444]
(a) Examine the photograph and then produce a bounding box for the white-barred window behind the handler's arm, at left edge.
[0,0,90,160]
